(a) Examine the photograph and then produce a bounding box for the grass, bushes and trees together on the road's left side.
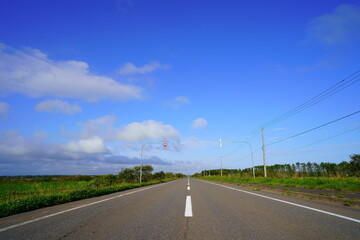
[0,165,185,217]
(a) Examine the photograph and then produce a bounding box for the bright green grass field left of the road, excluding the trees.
[0,181,170,217]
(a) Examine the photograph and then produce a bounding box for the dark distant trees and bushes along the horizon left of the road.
[0,165,185,186]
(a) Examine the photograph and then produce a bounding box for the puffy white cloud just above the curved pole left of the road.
[117,120,179,142]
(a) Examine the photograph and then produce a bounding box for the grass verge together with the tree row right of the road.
[194,154,360,192]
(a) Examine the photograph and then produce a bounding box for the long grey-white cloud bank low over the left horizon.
[0,131,177,175]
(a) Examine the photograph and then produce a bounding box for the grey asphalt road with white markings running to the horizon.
[0,179,360,240]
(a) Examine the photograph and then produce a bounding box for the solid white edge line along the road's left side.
[0,181,174,232]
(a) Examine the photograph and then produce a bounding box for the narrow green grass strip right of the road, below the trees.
[202,176,360,192]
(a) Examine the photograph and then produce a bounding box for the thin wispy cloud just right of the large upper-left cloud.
[117,62,171,75]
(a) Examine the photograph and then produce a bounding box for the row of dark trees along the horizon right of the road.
[194,154,360,177]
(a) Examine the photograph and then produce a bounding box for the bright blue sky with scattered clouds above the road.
[0,0,360,175]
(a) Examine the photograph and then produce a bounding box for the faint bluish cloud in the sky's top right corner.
[306,4,360,44]
